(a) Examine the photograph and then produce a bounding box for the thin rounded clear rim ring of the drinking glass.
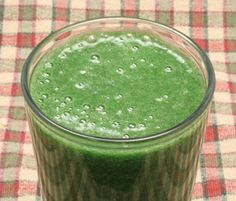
[21,16,215,143]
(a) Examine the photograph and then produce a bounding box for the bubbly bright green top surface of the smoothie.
[30,32,206,138]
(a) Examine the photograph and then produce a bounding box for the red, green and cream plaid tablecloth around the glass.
[0,0,236,201]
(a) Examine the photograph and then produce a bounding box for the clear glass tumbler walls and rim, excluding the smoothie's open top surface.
[21,17,215,201]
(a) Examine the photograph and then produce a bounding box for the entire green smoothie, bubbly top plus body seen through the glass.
[27,30,207,201]
